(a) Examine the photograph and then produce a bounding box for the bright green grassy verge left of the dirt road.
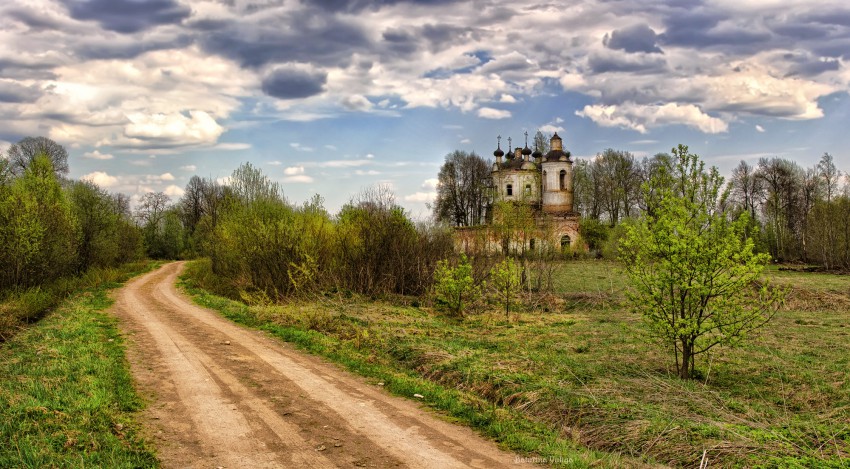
[0,264,157,468]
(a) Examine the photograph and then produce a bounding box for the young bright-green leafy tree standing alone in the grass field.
[620,145,783,379]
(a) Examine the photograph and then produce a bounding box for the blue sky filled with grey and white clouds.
[0,0,850,218]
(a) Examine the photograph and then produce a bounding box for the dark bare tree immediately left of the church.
[434,151,490,226]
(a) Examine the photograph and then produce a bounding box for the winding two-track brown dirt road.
[114,263,522,468]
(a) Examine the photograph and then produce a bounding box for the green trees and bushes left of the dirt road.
[0,137,144,342]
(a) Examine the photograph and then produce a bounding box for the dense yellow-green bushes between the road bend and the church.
[169,163,453,301]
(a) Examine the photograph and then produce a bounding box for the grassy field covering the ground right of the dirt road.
[188,261,850,467]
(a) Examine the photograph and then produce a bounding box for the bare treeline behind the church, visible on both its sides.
[433,149,850,270]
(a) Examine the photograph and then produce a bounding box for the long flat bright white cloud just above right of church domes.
[576,103,729,134]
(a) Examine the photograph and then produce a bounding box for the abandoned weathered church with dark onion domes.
[457,132,579,253]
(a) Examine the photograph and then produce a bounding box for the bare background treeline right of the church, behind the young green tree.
[575,150,850,270]
